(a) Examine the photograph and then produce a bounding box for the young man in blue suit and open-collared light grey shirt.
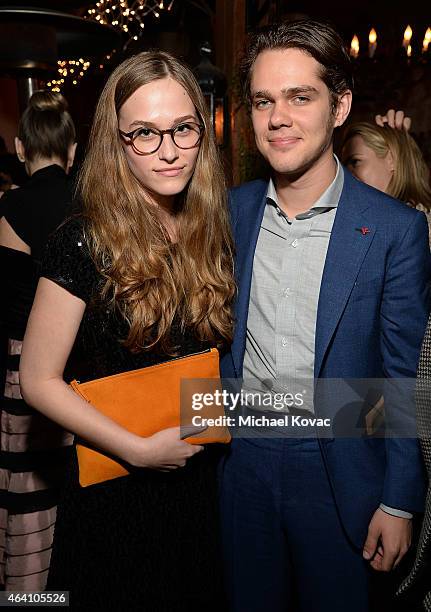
[221,20,430,612]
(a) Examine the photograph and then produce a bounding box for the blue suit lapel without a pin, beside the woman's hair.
[232,182,268,375]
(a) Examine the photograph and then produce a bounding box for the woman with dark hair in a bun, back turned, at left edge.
[0,91,76,591]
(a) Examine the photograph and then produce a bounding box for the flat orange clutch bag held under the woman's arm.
[70,349,231,487]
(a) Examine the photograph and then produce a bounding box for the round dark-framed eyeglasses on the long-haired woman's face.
[118,121,205,155]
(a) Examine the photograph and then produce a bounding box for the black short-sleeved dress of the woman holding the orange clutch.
[42,219,225,612]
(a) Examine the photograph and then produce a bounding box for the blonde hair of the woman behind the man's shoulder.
[342,121,431,210]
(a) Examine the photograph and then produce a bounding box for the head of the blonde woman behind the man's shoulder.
[341,122,431,243]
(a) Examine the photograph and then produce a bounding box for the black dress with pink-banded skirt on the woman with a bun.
[0,165,72,591]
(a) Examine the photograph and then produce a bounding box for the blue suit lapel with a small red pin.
[314,172,376,377]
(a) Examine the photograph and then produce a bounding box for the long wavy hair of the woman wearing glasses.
[77,51,235,354]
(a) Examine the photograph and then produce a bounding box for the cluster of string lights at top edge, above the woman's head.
[87,0,175,46]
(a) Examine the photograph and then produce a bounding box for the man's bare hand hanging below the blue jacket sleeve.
[363,508,412,572]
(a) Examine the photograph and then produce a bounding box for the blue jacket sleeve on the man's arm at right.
[380,214,431,512]
